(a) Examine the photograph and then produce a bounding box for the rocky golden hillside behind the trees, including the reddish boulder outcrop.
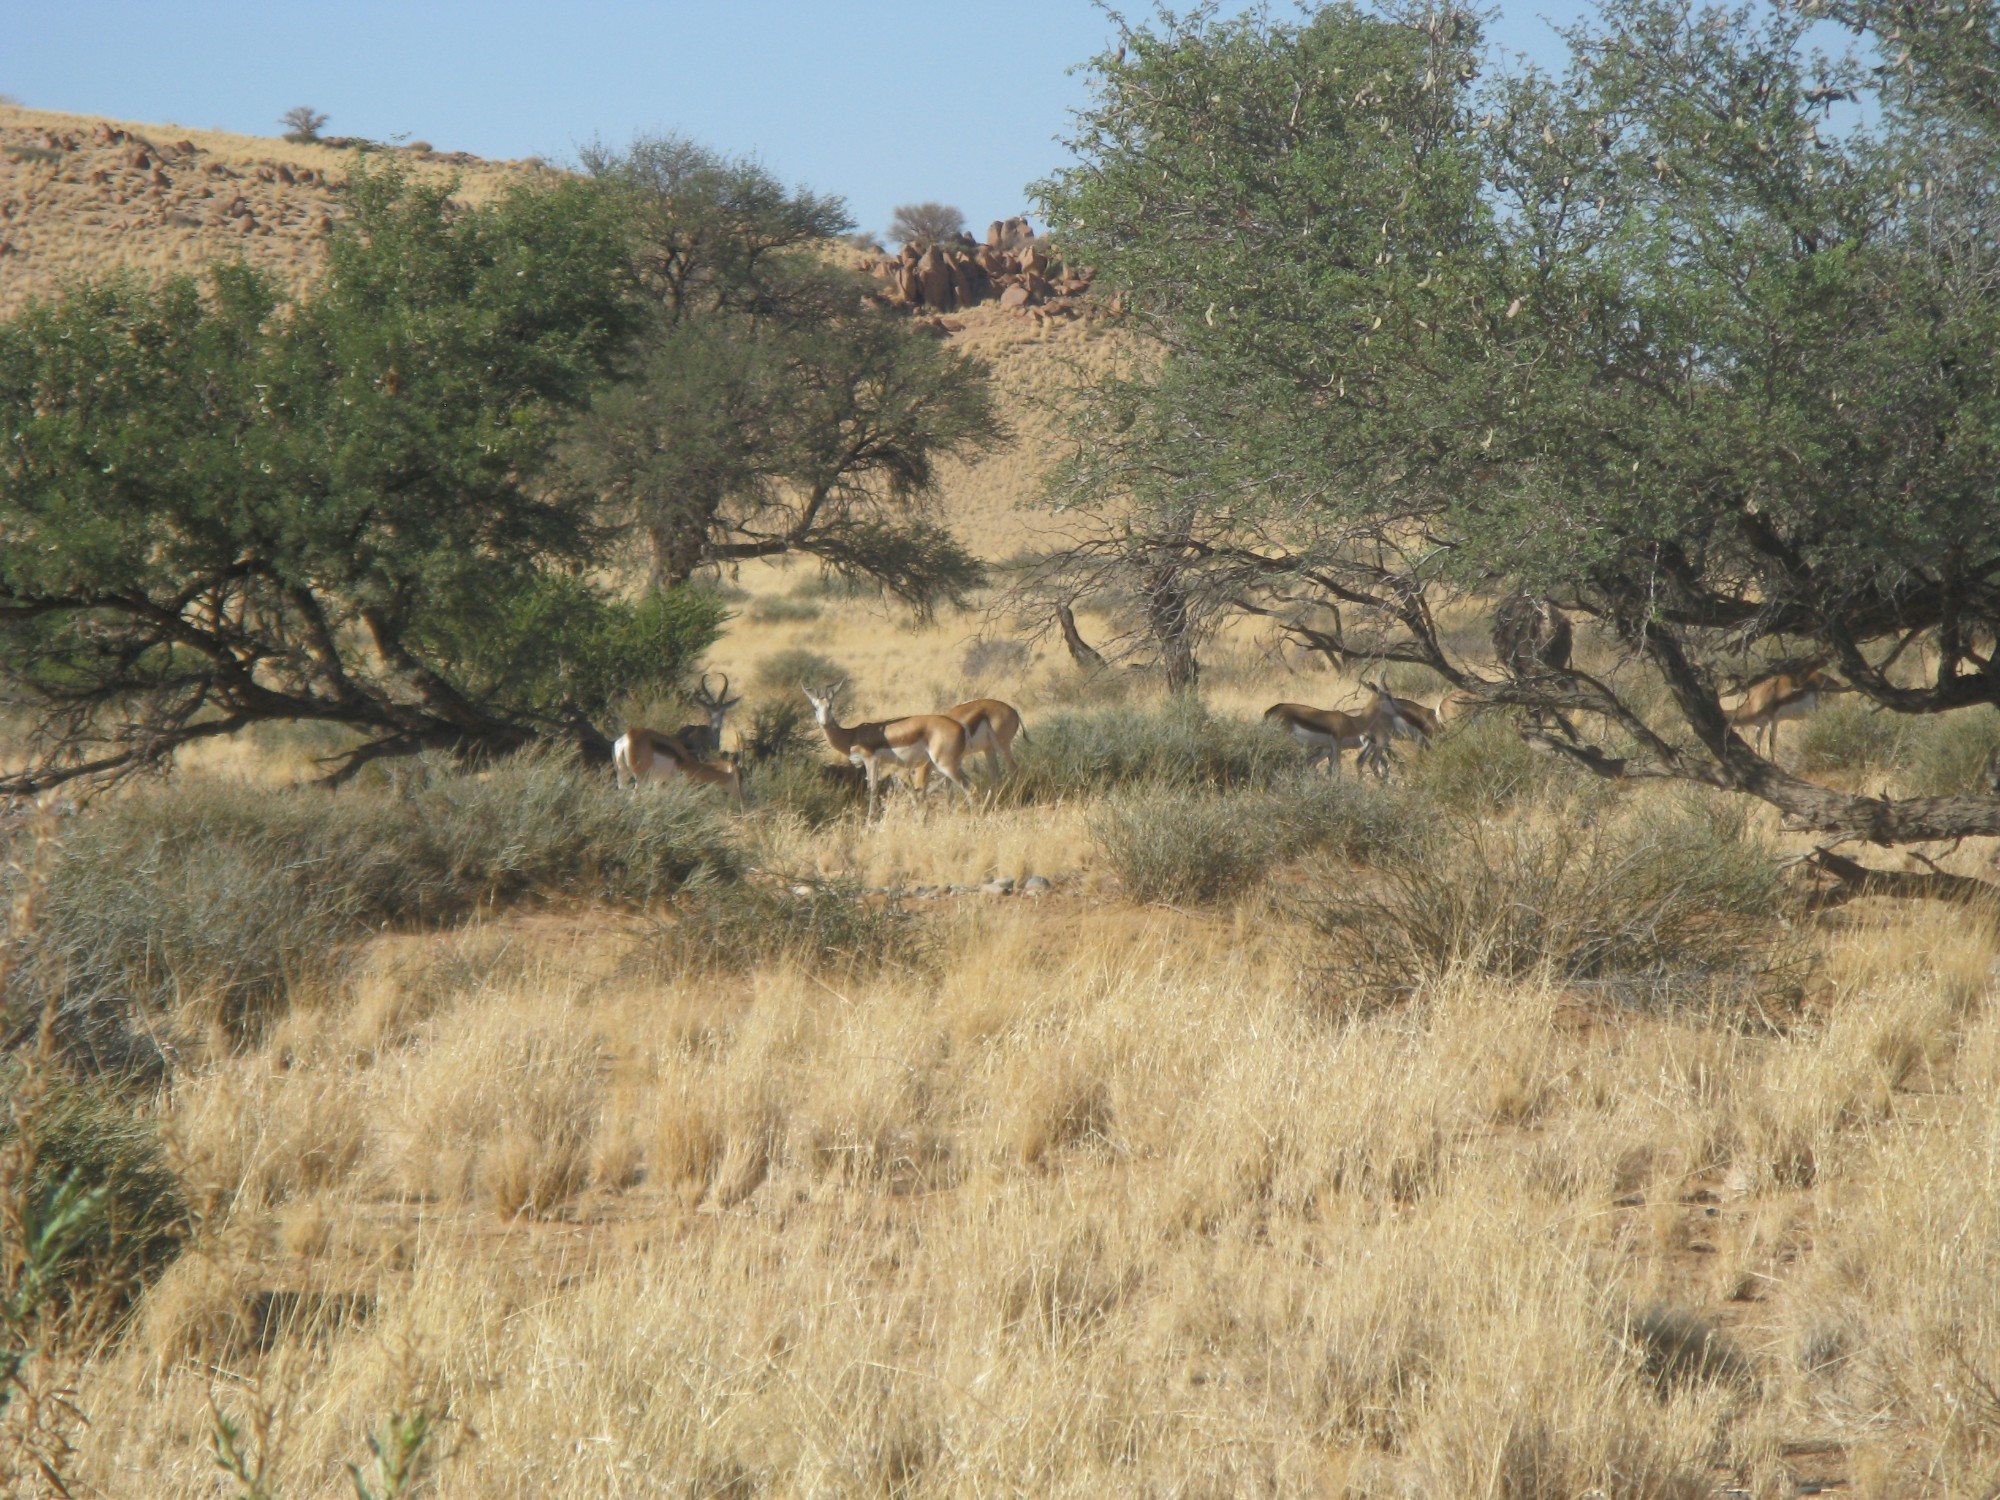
[0,106,1132,558]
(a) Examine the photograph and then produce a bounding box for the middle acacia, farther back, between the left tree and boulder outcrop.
[568,138,1006,610]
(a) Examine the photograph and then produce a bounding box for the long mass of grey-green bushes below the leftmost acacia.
[20,756,740,1048]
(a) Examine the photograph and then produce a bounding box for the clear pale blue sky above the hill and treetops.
[0,0,1594,234]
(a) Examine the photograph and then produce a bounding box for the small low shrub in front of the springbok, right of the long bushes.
[626,878,932,982]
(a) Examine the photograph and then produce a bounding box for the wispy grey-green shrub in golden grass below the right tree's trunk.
[1304,798,1796,994]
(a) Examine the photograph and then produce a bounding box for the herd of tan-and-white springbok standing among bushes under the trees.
[612,670,1852,820]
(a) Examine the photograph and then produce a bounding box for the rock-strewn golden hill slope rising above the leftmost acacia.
[0,106,536,318]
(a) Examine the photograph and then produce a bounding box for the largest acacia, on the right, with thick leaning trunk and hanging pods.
[1044,0,2000,894]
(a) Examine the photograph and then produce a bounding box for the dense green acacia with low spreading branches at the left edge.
[0,170,718,794]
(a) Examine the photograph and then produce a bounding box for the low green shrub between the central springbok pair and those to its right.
[1008,700,1304,802]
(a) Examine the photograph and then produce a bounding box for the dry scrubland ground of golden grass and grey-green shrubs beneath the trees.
[11,110,2000,1500]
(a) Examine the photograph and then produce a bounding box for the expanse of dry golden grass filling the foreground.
[50,864,2000,1496]
